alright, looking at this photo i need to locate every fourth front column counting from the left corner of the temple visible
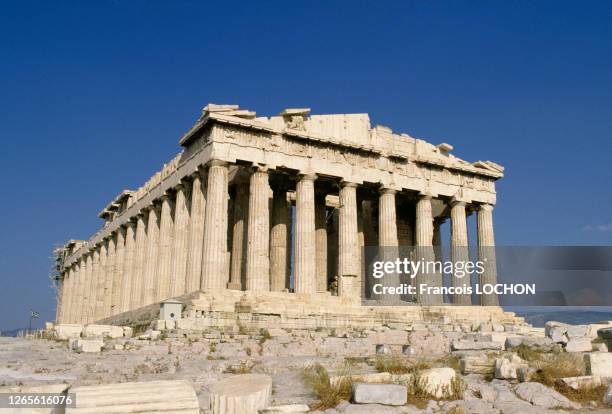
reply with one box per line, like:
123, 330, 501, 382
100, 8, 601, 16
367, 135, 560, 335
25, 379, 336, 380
338, 182, 360, 298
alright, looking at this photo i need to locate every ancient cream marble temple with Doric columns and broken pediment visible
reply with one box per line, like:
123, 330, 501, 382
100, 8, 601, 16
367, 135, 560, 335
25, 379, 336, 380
56, 104, 503, 323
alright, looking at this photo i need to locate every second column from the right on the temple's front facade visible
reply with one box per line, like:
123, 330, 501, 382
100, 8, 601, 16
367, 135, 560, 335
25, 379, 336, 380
451, 200, 472, 305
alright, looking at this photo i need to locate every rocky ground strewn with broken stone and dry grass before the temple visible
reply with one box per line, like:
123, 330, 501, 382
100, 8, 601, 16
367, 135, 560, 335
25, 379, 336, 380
0, 324, 612, 414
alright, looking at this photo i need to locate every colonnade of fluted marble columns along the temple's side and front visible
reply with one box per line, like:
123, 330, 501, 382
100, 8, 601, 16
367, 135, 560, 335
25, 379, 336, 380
58, 161, 496, 322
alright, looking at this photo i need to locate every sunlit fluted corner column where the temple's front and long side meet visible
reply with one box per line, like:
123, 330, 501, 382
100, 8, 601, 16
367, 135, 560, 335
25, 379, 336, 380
200, 160, 228, 289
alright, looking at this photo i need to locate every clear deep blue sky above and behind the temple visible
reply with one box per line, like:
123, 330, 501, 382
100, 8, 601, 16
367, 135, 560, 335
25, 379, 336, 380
0, 1, 612, 329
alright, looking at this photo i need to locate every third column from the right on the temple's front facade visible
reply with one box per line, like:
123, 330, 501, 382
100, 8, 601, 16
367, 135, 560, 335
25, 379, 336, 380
415, 194, 442, 305
